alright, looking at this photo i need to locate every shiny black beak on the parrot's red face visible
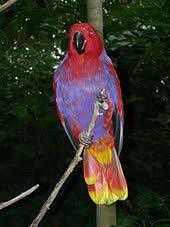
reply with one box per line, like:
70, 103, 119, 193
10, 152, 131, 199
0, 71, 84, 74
74, 32, 86, 54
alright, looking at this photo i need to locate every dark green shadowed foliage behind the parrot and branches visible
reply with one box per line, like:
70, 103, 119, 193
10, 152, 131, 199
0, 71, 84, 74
0, 0, 170, 227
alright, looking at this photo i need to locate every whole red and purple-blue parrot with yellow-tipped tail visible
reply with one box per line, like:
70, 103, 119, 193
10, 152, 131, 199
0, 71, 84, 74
53, 22, 128, 205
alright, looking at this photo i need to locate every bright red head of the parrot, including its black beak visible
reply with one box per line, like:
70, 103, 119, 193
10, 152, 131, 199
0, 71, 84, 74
68, 23, 103, 57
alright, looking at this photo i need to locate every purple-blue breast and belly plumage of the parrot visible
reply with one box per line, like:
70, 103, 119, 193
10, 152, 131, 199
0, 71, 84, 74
56, 59, 118, 141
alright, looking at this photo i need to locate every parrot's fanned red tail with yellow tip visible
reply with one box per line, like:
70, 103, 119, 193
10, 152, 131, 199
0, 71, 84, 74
83, 139, 128, 205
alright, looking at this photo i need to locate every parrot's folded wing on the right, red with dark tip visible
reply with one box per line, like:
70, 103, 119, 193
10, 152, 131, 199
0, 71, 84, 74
105, 58, 124, 155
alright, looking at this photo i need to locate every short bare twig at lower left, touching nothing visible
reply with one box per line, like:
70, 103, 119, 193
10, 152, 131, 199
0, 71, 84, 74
0, 184, 39, 210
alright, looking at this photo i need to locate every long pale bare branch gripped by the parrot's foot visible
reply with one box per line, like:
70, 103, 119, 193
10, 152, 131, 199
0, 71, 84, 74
29, 89, 107, 227
